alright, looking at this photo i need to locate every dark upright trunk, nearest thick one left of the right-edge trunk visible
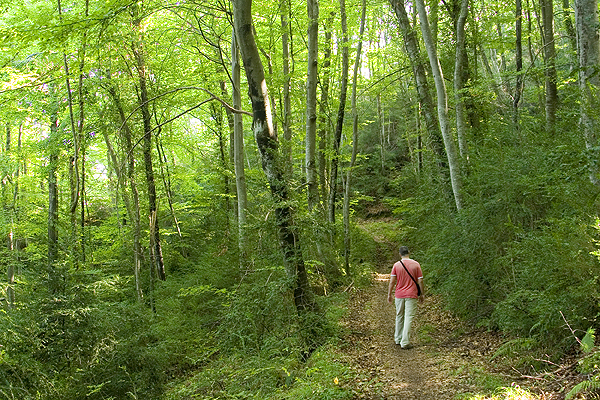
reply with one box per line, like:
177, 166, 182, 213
540, 0, 558, 135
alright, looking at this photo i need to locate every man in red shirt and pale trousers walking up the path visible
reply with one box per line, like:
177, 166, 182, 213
388, 246, 425, 350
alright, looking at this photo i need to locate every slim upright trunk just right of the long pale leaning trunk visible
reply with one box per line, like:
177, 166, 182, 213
454, 0, 469, 159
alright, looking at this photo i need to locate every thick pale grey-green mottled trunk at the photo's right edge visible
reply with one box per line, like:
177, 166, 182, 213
575, 0, 600, 186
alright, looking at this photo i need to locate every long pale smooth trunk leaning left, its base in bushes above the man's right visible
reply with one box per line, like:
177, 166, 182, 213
416, 0, 462, 211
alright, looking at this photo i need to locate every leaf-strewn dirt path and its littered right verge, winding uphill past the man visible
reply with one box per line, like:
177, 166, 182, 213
330, 219, 598, 400
